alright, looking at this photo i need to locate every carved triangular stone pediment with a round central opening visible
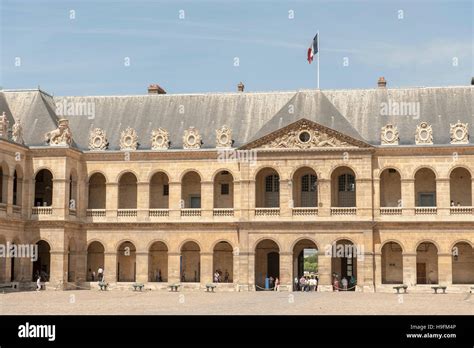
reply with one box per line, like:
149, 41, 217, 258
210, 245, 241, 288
242, 119, 372, 149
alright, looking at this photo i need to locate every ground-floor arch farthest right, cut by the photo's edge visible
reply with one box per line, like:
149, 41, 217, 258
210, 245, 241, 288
452, 242, 474, 284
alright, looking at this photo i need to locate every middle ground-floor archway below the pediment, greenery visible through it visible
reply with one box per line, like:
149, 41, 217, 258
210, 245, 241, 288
293, 239, 319, 290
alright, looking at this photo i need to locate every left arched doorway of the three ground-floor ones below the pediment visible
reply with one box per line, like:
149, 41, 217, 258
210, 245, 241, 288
255, 239, 280, 290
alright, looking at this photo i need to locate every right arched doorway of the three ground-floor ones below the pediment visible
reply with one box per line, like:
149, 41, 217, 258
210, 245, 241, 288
331, 239, 359, 291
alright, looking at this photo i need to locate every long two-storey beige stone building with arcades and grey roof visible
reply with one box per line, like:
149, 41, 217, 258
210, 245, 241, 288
0, 83, 474, 291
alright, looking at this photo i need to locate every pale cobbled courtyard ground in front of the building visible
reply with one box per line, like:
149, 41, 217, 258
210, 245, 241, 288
0, 290, 474, 315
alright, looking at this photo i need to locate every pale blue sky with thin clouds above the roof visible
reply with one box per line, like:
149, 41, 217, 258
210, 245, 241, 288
0, 0, 474, 95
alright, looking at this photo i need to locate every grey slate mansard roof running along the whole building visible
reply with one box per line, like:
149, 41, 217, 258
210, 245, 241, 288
0, 86, 474, 150
